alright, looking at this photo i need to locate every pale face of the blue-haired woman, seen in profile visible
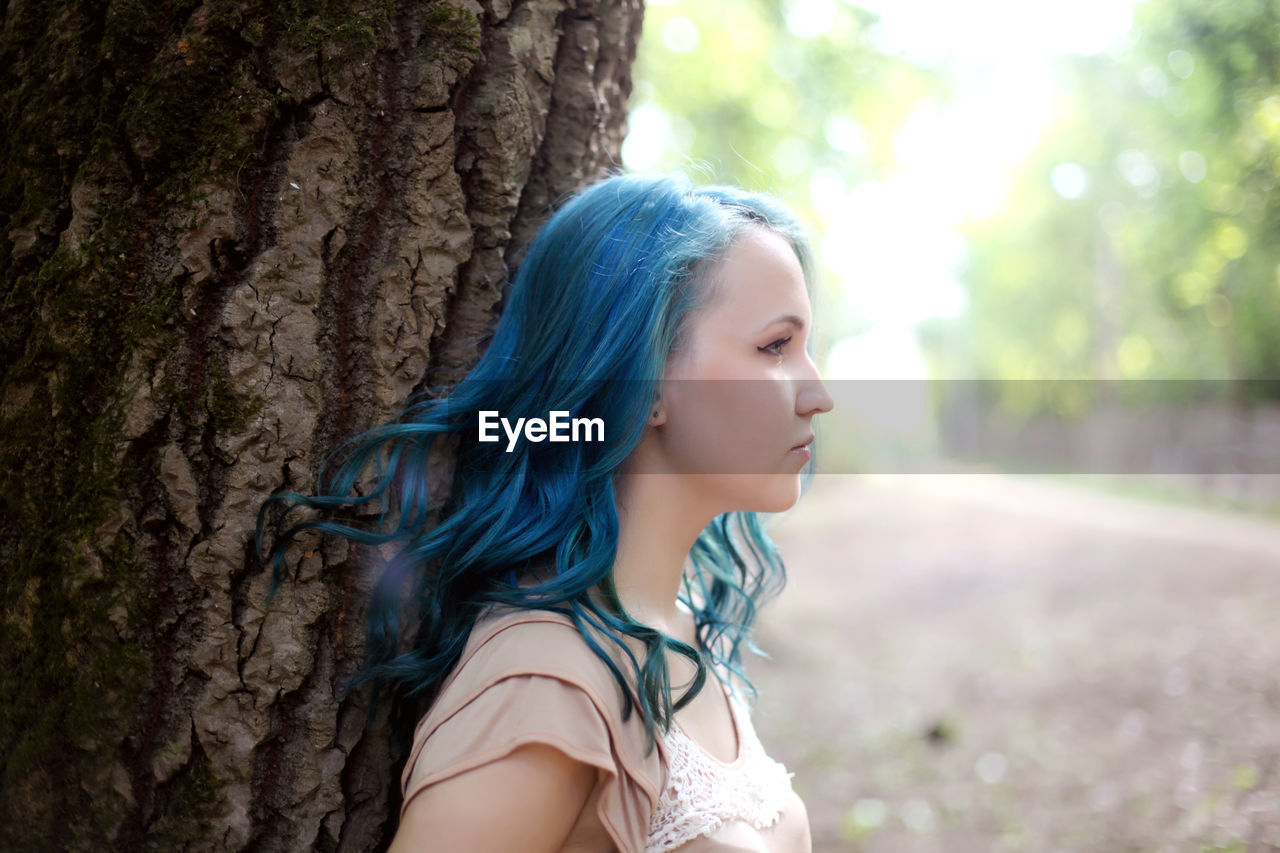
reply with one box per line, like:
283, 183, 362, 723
646, 227, 832, 515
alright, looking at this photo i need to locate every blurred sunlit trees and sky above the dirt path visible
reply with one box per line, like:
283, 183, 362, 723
622, 0, 1280, 504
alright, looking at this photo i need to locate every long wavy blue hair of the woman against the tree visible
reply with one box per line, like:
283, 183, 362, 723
255, 169, 813, 748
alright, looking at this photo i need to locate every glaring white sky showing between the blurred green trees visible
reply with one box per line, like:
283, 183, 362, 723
623, 0, 1138, 379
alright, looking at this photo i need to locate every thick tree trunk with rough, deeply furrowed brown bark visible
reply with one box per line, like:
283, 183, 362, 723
0, 0, 641, 850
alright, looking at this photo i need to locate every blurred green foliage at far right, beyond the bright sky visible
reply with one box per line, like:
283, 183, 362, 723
952, 0, 1280, 393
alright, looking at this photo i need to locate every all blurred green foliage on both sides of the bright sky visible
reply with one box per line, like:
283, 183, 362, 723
625, 0, 1280, 411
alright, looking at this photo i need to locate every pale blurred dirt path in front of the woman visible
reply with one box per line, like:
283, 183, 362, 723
751, 475, 1280, 853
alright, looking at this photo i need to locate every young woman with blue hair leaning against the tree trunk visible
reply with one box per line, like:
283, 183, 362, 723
259, 175, 832, 853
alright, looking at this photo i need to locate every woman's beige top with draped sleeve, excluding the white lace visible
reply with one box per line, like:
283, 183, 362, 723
401, 610, 809, 853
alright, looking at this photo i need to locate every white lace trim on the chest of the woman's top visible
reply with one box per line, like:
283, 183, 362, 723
645, 694, 794, 853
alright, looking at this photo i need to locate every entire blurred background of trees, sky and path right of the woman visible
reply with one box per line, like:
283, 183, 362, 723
622, 0, 1280, 850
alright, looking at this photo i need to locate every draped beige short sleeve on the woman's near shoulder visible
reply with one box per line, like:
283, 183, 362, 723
401, 616, 662, 853
